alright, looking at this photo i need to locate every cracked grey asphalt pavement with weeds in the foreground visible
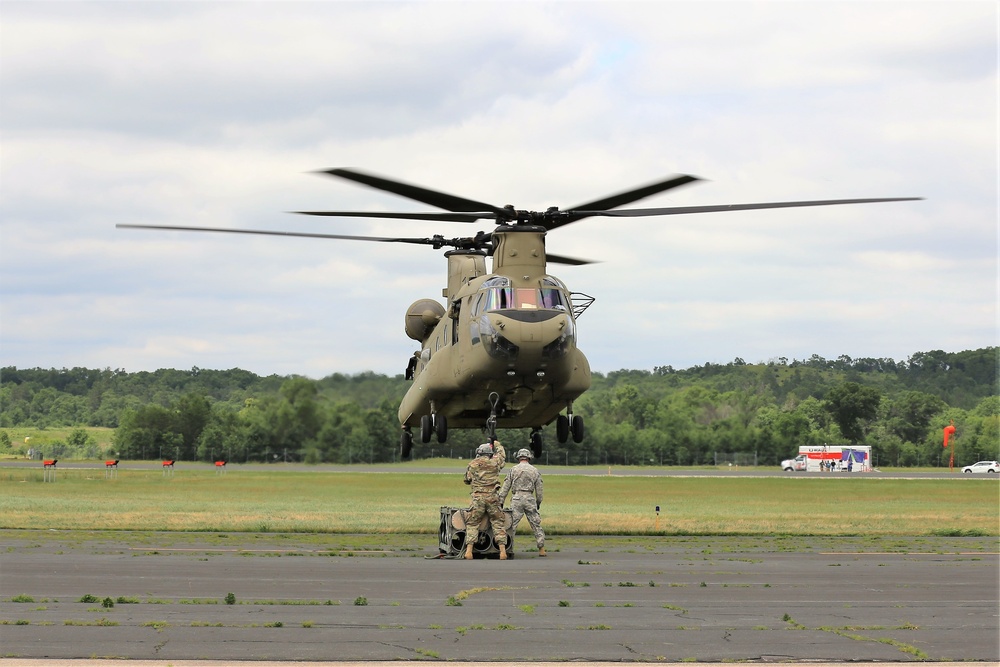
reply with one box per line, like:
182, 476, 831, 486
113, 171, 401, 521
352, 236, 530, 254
0, 531, 1000, 667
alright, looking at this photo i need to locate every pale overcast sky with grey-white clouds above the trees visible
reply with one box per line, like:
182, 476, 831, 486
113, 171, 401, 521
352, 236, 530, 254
0, 0, 998, 378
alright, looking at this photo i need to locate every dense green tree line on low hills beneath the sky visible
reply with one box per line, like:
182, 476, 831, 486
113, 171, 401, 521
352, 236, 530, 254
0, 347, 1000, 466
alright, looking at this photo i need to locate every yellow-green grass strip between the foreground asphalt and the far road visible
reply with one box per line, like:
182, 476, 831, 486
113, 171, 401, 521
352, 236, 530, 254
0, 468, 1000, 536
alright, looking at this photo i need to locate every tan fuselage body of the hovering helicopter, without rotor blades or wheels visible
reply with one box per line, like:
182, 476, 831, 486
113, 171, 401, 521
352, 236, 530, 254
399, 227, 590, 428
